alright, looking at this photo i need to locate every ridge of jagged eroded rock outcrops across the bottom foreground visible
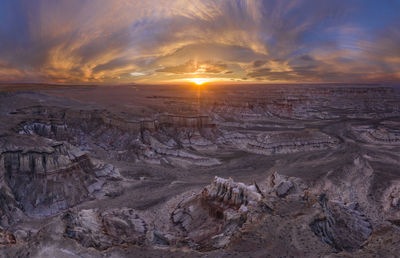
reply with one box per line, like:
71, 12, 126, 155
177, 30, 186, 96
59, 173, 384, 254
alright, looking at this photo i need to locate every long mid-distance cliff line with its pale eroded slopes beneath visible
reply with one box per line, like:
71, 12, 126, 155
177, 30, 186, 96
15, 107, 340, 166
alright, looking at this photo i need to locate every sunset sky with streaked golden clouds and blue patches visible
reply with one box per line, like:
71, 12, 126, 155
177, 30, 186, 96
0, 0, 400, 84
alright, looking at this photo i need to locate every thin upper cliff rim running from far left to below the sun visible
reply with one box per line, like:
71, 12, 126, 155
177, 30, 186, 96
13, 106, 215, 140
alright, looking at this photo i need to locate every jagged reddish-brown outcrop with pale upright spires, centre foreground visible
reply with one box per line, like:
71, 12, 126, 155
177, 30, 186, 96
171, 177, 268, 249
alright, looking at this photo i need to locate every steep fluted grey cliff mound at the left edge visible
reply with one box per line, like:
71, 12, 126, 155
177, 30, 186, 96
0, 152, 92, 215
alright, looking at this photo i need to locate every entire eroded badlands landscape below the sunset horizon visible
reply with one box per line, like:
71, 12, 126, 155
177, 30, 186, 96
0, 84, 400, 257
